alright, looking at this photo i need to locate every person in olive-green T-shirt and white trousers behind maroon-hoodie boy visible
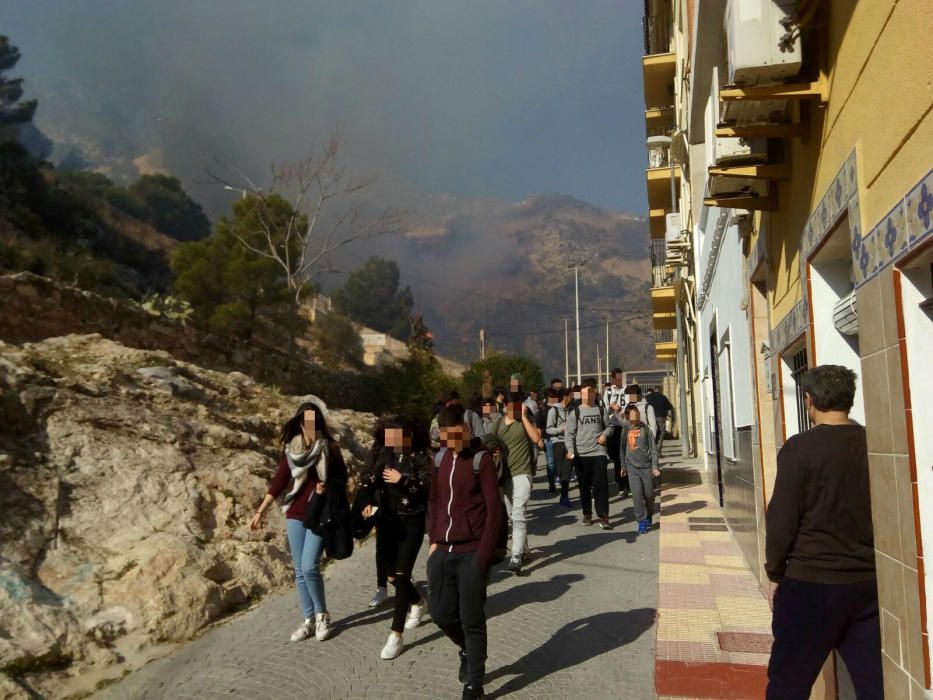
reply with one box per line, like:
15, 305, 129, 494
483, 391, 544, 574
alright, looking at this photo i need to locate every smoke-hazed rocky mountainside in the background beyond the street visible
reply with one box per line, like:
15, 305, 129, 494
355, 193, 656, 374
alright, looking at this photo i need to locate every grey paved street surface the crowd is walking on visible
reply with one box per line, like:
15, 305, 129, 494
99, 470, 659, 700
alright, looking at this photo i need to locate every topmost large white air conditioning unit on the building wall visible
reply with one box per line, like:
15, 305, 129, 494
725, 0, 802, 86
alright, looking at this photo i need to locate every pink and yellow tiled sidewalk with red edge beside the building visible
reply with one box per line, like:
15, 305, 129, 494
655, 449, 771, 698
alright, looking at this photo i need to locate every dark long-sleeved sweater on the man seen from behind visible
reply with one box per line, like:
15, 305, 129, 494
765, 423, 875, 583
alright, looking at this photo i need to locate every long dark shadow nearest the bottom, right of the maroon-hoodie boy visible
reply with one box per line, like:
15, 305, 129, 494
487, 608, 656, 697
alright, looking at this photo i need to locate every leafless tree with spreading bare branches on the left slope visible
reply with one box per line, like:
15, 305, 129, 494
208, 129, 407, 359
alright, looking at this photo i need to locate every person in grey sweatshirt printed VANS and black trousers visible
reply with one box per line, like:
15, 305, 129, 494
564, 384, 612, 530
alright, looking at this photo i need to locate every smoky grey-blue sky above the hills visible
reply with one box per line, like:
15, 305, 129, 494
0, 0, 646, 215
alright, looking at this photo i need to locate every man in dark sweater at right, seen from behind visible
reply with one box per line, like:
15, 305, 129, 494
765, 365, 889, 700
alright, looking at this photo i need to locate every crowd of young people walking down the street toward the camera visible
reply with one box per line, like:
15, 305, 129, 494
250, 372, 666, 698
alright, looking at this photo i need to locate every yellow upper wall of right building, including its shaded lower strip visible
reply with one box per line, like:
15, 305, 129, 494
764, 0, 933, 324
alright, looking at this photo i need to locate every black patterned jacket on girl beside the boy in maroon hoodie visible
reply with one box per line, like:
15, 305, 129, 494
357, 447, 431, 517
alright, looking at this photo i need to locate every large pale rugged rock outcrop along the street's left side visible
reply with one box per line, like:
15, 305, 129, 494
0, 335, 375, 697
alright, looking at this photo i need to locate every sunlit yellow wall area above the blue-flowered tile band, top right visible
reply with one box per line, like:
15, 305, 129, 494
811, 0, 933, 234
